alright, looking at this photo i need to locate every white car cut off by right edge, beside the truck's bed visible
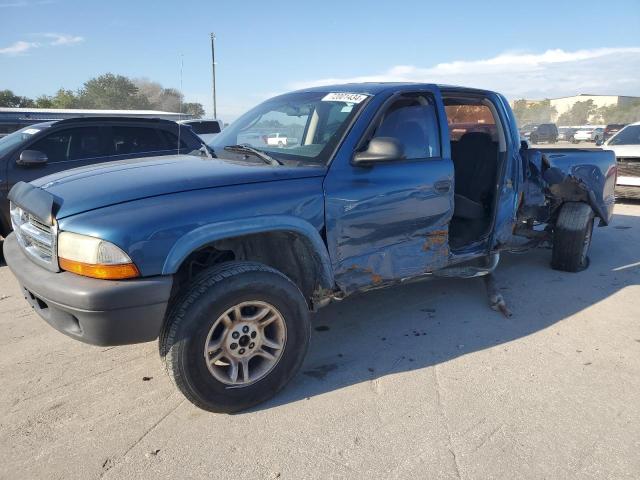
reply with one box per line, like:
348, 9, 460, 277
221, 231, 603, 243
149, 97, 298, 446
602, 122, 640, 199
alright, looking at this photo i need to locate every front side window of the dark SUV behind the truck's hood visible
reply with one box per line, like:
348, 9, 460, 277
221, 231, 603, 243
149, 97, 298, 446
29, 127, 108, 163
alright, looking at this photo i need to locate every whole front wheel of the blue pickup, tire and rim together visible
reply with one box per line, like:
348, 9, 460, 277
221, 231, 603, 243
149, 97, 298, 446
160, 262, 310, 413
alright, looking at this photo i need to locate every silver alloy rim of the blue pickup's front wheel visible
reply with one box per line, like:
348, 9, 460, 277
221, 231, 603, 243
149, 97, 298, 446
204, 300, 287, 387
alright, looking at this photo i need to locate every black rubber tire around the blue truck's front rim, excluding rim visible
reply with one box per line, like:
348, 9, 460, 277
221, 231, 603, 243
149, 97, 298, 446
159, 262, 311, 413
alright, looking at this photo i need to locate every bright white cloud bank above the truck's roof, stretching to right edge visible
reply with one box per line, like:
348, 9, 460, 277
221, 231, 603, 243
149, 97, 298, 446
292, 47, 640, 98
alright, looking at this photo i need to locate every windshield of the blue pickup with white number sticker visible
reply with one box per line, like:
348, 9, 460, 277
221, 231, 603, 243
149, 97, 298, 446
209, 92, 368, 164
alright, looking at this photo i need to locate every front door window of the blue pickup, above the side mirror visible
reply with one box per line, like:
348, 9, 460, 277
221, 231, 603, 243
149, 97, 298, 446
374, 96, 440, 160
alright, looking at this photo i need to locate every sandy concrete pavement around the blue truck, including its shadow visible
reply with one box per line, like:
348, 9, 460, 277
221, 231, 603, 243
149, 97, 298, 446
0, 204, 640, 479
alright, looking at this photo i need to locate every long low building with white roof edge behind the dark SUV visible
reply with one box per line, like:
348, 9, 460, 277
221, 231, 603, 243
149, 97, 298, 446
0, 107, 193, 137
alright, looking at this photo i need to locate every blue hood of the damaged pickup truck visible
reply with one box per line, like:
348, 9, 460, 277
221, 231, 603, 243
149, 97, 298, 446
32, 155, 326, 219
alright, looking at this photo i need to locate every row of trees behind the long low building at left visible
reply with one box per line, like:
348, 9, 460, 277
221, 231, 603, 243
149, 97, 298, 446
0, 73, 204, 118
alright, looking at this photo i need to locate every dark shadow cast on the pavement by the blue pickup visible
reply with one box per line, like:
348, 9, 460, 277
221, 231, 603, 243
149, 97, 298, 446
253, 214, 640, 410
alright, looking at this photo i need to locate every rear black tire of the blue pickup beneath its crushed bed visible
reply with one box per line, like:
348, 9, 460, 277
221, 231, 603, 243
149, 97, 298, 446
551, 202, 594, 272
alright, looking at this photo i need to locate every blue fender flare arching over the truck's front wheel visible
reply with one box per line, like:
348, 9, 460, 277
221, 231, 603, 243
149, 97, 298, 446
162, 215, 335, 290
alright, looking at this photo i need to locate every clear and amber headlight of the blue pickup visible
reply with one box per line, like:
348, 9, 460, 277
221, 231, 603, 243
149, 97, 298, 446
58, 232, 140, 280
